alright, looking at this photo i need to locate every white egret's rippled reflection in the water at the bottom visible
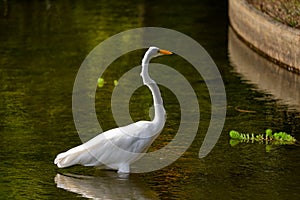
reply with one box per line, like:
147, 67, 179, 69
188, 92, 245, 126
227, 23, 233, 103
54, 171, 159, 199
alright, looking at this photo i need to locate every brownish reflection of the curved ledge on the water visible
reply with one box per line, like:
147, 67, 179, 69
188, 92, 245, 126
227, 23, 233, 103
228, 28, 300, 111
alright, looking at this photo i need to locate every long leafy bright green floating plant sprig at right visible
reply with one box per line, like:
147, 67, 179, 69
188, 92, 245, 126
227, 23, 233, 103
229, 129, 296, 146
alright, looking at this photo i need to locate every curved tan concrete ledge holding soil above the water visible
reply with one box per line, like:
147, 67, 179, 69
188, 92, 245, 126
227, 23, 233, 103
229, 0, 300, 74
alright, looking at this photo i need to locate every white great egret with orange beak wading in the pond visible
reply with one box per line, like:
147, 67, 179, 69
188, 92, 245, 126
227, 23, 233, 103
54, 47, 172, 173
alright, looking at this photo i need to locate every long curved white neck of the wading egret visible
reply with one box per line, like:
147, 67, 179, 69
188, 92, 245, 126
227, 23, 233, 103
141, 56, 166, 125
